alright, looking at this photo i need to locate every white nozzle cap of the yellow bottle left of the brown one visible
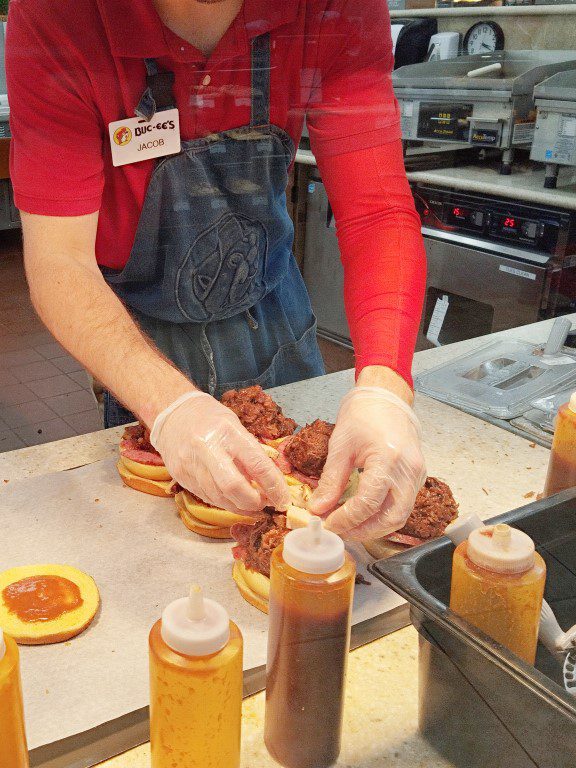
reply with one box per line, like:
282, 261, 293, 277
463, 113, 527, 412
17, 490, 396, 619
160, 584, 230, 656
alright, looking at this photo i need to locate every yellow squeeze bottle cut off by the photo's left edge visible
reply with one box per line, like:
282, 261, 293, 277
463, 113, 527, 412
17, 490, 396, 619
0, 629, 28, 768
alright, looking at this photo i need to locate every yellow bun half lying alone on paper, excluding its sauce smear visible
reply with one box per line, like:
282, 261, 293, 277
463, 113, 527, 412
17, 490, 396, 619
0, 564, 100, 645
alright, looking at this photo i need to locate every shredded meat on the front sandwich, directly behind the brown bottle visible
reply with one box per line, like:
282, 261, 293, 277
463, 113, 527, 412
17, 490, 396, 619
230, 507, 288, 576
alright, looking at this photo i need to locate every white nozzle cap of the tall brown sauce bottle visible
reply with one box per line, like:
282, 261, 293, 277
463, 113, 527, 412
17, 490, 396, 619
282, 515, 345, 573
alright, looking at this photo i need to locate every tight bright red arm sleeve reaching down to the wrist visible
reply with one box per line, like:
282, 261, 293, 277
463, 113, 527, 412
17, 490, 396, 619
310, 141, 426, 386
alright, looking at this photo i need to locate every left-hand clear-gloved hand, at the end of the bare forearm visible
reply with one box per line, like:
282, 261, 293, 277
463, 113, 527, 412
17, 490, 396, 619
150, 391, 290, 514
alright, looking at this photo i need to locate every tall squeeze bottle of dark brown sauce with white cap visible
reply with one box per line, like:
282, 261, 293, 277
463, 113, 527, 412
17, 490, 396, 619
264, 517, 356, 768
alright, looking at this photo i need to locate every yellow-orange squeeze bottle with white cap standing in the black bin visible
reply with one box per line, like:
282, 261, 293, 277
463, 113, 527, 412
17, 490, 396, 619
450, 523, 546, 664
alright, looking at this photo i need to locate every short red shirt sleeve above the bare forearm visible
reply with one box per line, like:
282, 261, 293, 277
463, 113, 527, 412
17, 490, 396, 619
6, 0, 104, 216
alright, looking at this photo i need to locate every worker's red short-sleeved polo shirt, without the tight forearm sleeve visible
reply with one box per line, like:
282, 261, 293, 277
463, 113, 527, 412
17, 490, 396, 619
7, 0, 398, 268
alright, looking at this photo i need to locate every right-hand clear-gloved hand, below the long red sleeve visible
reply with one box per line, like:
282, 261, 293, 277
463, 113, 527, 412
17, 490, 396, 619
309, 386, 426, 540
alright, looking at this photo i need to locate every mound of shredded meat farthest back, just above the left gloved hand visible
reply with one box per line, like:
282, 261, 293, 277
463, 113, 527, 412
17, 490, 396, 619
222, 386, 296, 440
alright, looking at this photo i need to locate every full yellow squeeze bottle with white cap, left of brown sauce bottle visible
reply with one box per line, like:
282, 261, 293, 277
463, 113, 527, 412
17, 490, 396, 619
149, 586, 242, 768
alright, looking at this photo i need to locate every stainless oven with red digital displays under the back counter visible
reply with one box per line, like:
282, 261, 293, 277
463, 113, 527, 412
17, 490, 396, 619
303, 177, 576, 349
